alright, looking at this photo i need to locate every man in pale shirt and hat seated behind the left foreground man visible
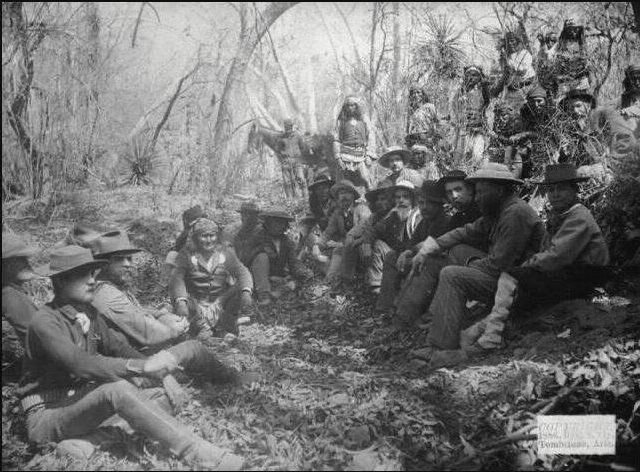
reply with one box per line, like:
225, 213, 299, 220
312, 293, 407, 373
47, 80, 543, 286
91, 231, 189, 349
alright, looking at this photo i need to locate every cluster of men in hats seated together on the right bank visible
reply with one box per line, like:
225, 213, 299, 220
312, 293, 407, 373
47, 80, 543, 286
290, 159, 609, 367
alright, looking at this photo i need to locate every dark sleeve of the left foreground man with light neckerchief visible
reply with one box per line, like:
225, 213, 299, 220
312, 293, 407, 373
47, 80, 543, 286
29, 316, 139, 381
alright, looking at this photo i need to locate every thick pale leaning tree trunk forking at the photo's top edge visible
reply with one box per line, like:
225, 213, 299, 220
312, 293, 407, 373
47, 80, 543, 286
207, 2, 297, 204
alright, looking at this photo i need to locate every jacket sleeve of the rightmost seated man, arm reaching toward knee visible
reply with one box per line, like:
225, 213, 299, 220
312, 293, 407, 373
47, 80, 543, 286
522, 211, 591, 272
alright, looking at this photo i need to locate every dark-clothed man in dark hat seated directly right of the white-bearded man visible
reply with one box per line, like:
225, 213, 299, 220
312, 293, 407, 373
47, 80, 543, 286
376, 180, 448, 322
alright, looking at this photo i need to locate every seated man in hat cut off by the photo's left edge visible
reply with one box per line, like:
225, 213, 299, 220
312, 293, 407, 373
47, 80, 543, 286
2, 233, 38, 378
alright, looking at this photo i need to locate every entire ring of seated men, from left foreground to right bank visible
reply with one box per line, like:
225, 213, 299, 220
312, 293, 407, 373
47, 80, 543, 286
2, 156, 609, 464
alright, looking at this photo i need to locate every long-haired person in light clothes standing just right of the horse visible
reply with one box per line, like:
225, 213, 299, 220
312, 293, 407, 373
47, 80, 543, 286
333, 95, 376, 193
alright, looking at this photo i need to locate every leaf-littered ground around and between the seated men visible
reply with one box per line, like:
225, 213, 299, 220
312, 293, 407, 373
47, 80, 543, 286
2, 184, 640, 470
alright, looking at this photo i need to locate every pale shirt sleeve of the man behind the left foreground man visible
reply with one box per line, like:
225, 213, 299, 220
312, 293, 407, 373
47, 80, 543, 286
93, 284, 174, 346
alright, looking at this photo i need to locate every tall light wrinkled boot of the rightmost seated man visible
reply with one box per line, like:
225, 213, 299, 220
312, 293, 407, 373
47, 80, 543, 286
460, 272, 518, 350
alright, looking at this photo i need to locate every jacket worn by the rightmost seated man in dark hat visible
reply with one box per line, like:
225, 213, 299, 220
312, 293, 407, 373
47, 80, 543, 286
522, 204, 609, 272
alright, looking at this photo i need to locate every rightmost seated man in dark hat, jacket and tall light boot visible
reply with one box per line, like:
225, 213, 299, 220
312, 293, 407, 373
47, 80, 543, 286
460, 164, 609, 352
